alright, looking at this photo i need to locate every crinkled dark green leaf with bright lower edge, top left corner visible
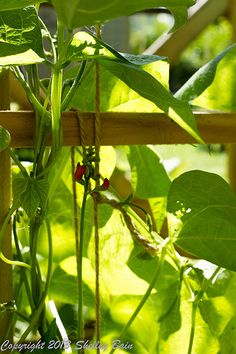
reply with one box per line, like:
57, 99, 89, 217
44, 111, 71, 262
0, 6, 44, 66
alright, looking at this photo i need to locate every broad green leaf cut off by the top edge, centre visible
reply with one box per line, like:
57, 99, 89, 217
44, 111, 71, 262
51, 0, 195, 29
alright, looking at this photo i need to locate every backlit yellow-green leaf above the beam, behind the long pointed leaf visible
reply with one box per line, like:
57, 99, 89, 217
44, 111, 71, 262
66, 55, 169, 112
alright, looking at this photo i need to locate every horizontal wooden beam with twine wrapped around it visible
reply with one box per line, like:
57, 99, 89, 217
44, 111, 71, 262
0, 111, 236, 147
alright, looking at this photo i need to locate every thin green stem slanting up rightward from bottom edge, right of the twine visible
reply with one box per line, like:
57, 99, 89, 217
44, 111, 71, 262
109, 239, 170, 354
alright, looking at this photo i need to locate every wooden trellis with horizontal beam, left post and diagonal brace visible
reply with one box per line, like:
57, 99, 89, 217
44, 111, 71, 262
0, 0, 236, 340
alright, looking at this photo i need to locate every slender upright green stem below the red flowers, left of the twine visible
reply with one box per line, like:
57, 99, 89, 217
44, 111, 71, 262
76, 181, 88, 340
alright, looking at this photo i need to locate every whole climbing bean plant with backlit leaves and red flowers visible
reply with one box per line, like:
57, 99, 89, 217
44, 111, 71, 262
0, 0, 236, 354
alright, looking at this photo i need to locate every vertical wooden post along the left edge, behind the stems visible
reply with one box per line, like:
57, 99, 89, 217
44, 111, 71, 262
0, 71, 13, 346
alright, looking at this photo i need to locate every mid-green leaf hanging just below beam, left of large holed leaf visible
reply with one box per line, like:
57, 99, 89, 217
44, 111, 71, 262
128, 145, 170, 198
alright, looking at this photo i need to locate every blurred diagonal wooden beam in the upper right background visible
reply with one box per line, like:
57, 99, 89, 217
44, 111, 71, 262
144, 0, 228, 62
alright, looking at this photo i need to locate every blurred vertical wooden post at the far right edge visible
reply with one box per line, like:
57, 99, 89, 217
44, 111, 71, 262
227, 0, 236, 193
